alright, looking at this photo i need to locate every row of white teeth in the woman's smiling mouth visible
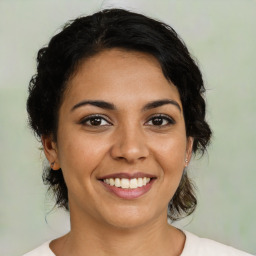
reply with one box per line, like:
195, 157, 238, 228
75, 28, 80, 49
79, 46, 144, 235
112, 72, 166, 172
104, 177, 150, 188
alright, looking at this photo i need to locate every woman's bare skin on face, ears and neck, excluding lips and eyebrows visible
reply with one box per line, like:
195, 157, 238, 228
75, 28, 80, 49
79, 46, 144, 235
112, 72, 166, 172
42, 49, 193, 256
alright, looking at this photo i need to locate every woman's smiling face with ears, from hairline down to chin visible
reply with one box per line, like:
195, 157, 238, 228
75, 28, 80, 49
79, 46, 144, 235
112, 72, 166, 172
45, 49, 192, 228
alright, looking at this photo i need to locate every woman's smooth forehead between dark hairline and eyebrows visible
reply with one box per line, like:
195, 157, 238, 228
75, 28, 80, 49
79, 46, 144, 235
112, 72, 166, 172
64, 48, 180, 109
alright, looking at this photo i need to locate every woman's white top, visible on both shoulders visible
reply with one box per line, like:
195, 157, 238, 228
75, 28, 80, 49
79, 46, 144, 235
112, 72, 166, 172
23, 231, 253, 256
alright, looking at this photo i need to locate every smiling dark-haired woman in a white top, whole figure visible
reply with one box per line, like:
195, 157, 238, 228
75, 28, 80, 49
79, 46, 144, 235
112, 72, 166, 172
23, 9, 252, 256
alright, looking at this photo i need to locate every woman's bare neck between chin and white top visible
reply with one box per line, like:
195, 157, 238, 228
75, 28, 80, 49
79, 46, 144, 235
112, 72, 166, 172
51, 206, 185, 256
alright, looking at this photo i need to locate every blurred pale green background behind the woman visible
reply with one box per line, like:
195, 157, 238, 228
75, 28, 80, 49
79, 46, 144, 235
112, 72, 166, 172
0, 0, 256, 256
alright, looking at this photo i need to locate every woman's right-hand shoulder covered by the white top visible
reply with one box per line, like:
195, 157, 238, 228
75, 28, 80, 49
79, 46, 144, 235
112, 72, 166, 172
181, 231, 252, 256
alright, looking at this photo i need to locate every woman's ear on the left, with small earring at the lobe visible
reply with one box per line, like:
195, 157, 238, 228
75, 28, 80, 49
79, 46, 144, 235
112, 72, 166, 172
41, 135, 60, 170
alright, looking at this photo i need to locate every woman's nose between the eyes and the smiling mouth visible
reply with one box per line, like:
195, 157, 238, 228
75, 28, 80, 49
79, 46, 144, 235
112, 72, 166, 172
111, 125, 149, 163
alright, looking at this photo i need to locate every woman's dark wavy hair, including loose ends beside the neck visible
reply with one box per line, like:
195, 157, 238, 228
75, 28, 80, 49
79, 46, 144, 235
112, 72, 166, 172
27, 9, 211, 221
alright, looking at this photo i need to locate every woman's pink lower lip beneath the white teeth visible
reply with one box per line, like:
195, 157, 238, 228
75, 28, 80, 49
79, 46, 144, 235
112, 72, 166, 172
101, 179, 155, 199
